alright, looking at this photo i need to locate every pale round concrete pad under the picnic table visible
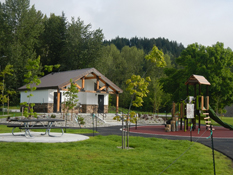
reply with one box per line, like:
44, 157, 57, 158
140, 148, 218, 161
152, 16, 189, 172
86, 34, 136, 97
0, 132, 89, 143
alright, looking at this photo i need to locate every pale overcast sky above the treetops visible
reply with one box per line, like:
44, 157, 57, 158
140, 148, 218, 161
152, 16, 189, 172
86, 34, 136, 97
1, 0, 233, 49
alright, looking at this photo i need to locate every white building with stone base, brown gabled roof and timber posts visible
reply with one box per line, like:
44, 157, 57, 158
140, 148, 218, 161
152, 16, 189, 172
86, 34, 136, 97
18, 68, 123, 113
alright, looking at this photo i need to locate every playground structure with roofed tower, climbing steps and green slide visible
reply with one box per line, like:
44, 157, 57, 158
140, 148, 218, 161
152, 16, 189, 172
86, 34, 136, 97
165, 75, 233, 132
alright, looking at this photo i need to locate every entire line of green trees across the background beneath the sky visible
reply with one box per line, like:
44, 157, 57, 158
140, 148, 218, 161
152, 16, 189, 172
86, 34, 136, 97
0, 0, 233, 112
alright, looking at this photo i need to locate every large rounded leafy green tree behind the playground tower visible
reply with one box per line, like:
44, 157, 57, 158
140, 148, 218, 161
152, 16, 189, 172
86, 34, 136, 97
161, 42, 233, 111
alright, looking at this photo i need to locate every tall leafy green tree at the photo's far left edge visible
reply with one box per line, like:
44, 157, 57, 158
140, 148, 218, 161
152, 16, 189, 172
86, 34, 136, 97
0, 0, 43, 104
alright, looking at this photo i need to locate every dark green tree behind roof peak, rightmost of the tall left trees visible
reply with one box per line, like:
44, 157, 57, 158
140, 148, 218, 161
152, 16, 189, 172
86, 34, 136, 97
61, 18, 103, 70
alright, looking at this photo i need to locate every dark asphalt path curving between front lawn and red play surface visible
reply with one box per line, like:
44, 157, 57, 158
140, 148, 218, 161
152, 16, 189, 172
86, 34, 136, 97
82, 126, 233, 161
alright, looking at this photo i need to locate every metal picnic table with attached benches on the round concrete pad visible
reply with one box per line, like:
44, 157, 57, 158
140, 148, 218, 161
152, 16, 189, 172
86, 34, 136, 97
7, 118, 67, 137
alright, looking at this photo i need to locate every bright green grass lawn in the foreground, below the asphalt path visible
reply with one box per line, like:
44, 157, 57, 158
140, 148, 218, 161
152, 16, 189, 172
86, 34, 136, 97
0, 135, 233, 175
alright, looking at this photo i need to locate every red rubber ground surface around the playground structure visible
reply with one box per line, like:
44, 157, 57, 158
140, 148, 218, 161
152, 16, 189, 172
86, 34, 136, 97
130, 125, 233, 138
